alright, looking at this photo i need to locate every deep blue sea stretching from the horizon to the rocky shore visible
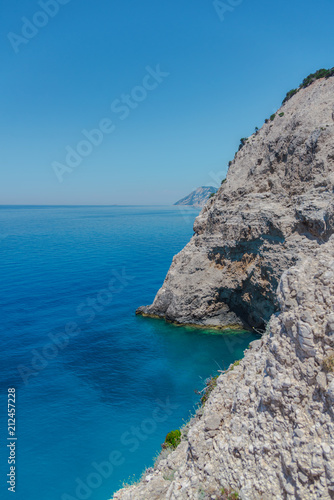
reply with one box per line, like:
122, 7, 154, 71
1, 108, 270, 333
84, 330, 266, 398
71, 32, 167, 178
0, 206, 255, 500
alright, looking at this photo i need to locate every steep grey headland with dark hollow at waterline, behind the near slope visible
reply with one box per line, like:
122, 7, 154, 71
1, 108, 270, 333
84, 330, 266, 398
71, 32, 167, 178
138, 78, 334, 327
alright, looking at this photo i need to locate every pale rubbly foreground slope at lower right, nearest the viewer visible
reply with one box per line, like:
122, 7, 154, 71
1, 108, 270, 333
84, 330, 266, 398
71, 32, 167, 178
114, 240, 334, 500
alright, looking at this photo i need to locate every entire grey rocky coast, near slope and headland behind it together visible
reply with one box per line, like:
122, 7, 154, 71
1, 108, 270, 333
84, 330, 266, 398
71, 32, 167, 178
114, 78, 334, 500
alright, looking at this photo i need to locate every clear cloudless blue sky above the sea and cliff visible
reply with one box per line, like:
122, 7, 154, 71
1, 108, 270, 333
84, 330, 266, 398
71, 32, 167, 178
0, 0, 334, 205
